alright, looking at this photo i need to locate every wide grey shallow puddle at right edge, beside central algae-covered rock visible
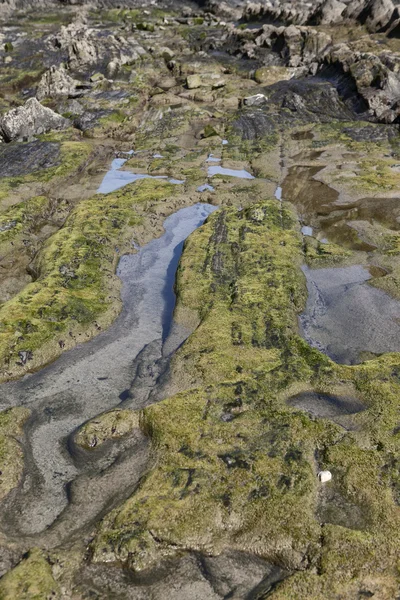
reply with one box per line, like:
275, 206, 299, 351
299, 265, 400, 364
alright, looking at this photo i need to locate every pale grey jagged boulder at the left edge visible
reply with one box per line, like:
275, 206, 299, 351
0, 98, 70, 142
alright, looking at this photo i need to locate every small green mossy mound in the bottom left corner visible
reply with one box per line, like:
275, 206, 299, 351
0, 548, 60, 600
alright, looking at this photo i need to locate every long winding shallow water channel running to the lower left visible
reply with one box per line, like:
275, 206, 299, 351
0, 203, 218, 543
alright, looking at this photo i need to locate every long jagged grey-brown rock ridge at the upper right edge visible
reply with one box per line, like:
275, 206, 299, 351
225, 11, 400, 123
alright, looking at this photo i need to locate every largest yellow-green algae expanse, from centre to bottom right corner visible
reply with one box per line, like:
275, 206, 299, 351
92, 201, 400, 599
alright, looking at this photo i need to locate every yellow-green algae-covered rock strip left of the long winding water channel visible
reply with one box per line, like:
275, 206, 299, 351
0, 180, 176, 378
